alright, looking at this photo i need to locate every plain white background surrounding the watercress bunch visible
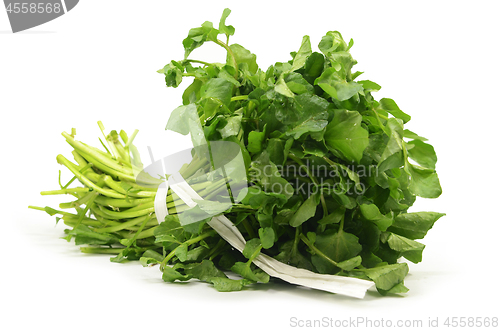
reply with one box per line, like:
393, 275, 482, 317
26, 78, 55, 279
0, 0, 500, 330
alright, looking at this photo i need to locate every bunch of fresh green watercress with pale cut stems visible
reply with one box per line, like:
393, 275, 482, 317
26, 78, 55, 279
32, 9, 444, 294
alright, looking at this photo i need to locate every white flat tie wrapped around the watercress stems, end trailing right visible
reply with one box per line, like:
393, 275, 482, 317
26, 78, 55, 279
155, 173, 375, 299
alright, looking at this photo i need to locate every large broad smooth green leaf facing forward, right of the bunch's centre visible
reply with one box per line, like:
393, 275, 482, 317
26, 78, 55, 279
324, 109, 369, 162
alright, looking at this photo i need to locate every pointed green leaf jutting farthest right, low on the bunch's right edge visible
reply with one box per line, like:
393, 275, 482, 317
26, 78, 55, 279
388, 211, 446, 239
